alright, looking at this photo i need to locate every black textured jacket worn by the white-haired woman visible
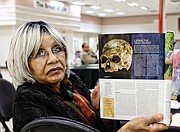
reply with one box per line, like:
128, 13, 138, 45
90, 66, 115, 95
13, 73, 102, 132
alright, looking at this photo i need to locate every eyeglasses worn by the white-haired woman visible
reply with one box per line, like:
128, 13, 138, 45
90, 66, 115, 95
30, 45, 65, 58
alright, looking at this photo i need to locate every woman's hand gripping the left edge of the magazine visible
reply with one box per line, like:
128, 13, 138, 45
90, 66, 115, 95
90, 83, 100, 111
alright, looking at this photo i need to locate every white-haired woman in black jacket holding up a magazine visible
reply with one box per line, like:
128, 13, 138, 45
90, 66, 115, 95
8, 21, 168, 132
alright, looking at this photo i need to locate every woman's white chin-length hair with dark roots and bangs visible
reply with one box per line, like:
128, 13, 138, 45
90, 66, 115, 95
7, 21, 70, 86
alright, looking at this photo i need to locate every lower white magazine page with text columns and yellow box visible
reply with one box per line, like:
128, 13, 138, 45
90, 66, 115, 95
100, 79, 171, 124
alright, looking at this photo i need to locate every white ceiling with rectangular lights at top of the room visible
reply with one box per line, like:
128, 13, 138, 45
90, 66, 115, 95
57, 0, 180, 18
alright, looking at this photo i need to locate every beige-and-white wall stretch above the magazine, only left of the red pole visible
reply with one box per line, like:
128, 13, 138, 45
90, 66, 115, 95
102, 15, 158, 33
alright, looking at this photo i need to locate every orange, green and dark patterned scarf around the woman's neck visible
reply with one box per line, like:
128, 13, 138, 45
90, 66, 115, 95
48, 78, 96, 126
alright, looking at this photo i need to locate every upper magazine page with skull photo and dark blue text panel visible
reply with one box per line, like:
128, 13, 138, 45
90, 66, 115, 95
99, 33, 165, 80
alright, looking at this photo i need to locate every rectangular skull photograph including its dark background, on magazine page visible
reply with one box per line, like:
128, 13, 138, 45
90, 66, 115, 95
99, 35, 133, 78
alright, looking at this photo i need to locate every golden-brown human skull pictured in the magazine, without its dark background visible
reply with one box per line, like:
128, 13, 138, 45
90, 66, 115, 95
100, 39, 133, 72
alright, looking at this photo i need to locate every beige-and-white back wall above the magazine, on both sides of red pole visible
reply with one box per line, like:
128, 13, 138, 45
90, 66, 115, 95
102, 14, 180, 40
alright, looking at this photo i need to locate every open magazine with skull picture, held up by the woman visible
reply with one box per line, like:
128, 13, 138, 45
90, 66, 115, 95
99, 33, 172, 125
